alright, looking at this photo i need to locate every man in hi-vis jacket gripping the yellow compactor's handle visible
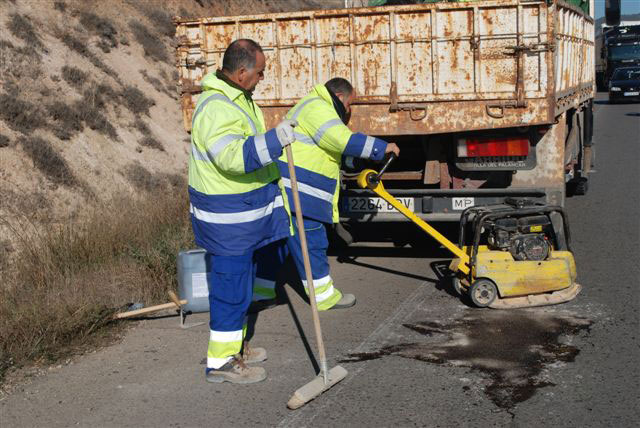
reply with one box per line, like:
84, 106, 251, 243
254, 78, 400, 311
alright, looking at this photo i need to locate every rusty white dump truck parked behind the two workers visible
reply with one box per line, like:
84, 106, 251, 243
175, 0, 595, 234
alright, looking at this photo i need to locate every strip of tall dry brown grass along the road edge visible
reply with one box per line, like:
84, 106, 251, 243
0, 189, 193, 382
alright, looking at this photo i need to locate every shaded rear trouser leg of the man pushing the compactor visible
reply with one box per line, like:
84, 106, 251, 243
253, 239, 289, 301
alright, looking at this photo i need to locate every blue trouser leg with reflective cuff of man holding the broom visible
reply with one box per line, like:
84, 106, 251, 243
205, 252, 254, 369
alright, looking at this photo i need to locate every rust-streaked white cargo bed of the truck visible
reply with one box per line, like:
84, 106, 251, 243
177, 0, 593, 135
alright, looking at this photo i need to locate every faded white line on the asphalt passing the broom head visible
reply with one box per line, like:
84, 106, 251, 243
277, 281, 433, 428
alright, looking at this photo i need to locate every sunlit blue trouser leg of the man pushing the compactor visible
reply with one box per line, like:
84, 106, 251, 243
287, 217, 342, 311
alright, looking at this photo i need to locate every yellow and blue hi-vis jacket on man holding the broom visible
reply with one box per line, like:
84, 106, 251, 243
189, 73, 290, 255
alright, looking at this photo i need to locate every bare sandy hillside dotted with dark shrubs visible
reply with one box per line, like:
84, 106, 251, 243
0, 0, 335, 261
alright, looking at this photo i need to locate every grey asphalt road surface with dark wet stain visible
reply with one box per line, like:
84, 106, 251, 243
0, 95, 640, 427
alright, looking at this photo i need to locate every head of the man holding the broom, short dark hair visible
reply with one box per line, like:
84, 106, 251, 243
222, 39, 265, 92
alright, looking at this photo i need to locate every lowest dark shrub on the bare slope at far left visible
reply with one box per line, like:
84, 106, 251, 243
18, 137, 78, 186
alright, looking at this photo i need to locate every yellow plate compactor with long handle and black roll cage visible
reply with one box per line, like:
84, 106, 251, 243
358, 155, 582, 309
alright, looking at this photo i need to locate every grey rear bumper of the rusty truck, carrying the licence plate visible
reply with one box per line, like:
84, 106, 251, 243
340, 188, 557, 223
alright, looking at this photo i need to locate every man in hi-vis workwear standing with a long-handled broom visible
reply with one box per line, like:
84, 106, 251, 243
189, 39, 295, 383
